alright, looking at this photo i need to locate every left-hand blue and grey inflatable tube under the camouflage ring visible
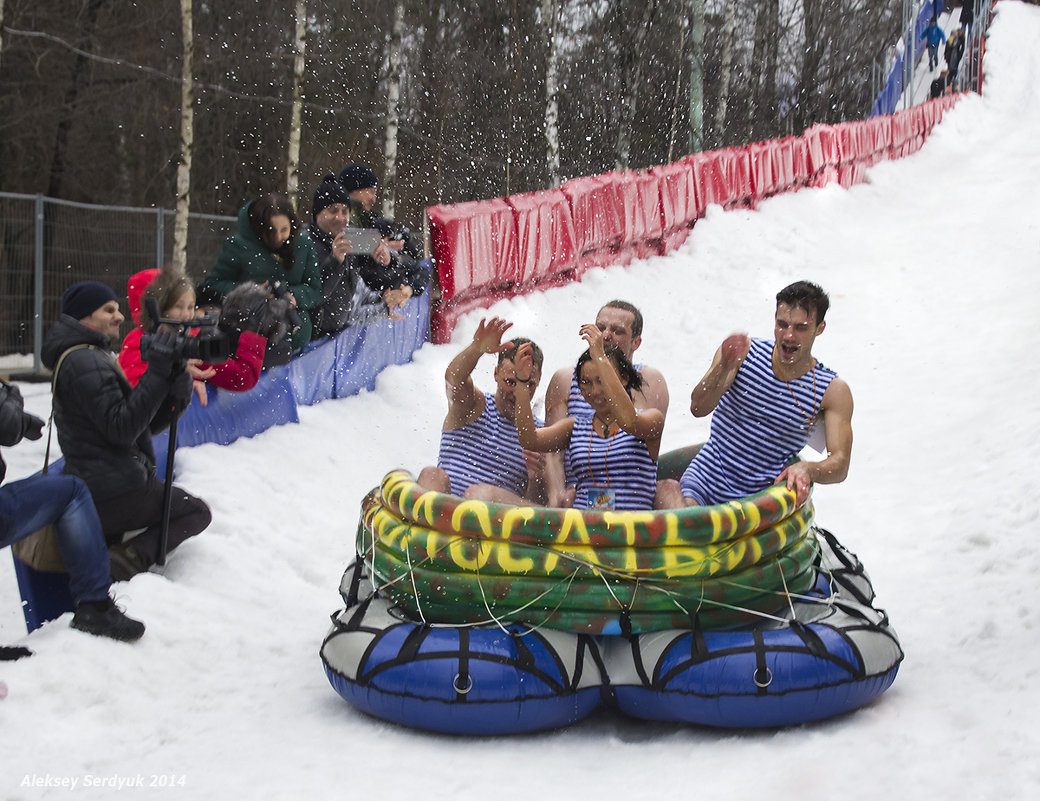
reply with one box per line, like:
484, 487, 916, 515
321, 563, 605, 734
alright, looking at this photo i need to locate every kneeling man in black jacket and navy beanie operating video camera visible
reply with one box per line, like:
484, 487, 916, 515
43, 281, 211, 580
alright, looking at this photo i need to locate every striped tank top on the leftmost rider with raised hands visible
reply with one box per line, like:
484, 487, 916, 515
437, 392, 542, 495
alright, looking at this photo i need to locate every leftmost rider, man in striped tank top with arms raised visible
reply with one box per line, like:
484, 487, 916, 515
418, 317, 544, 500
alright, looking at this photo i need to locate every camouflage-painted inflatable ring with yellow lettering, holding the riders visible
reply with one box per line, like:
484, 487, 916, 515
358, 471, 818, 634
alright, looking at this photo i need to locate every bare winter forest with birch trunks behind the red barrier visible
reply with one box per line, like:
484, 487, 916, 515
0, 0, 903, 234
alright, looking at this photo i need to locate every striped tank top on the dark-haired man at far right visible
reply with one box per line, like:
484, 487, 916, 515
680, 339, 837, 505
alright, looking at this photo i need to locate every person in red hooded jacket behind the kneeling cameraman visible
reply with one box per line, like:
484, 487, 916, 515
120, 266, 289, 406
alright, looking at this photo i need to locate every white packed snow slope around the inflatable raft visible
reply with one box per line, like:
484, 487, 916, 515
0, 0, 1040, 801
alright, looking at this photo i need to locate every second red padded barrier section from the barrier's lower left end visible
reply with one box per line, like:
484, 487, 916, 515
505, 189, 578, 284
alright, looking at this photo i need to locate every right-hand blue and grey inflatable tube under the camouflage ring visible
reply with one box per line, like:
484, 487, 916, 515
603, 529, 903, 728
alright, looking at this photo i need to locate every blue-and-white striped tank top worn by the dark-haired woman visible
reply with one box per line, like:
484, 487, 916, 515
565, 414, 657, 511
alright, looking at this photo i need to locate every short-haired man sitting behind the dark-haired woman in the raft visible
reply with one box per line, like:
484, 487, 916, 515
545, 301, 668, 507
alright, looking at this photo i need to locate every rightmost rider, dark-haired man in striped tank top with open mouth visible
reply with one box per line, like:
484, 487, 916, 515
657, 281, 853, 509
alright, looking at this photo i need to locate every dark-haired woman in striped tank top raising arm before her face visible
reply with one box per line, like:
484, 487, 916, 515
516, 324, 665, 510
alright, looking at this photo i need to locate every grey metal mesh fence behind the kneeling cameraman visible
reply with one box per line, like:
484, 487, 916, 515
0, 192, 237, 374
